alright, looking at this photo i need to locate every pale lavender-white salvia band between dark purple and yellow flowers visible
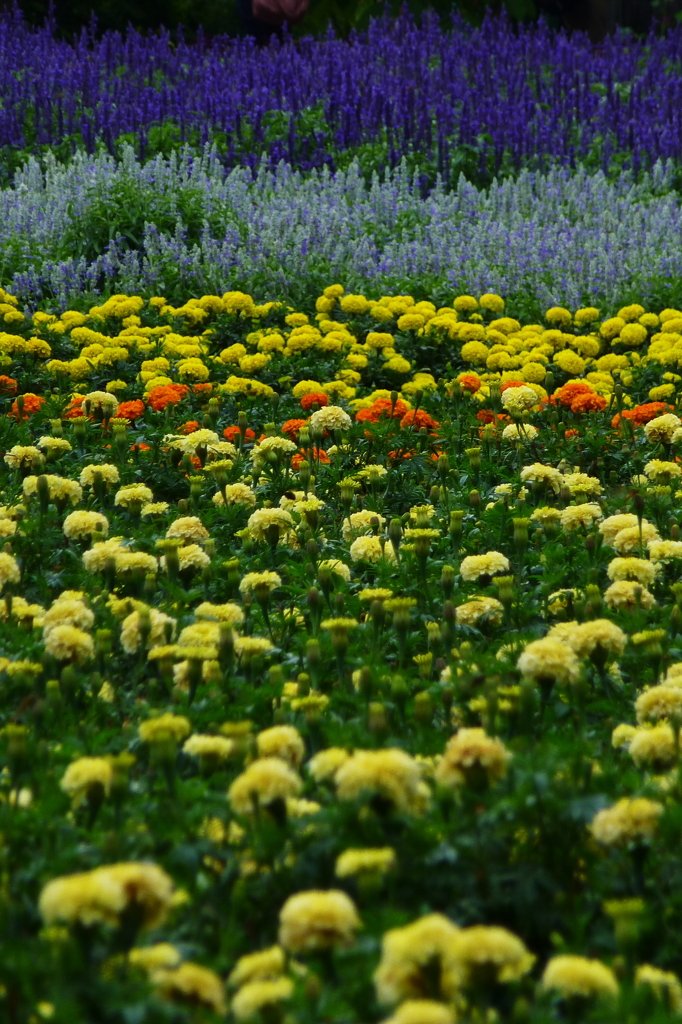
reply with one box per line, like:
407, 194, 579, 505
0, 148, 682, 307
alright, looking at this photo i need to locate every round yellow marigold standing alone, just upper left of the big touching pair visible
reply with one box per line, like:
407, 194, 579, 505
280, 889, 360, 952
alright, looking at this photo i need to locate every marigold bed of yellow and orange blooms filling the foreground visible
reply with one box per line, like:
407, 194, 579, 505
0, 285, 682, 1024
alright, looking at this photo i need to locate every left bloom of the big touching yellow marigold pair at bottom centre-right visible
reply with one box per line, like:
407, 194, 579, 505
374, 913, 460, 1006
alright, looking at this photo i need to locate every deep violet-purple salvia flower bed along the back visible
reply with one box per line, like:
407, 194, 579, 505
0, 9, 682, 183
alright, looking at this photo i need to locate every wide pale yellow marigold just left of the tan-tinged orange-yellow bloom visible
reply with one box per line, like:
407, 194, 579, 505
334, 748, 429, 814
